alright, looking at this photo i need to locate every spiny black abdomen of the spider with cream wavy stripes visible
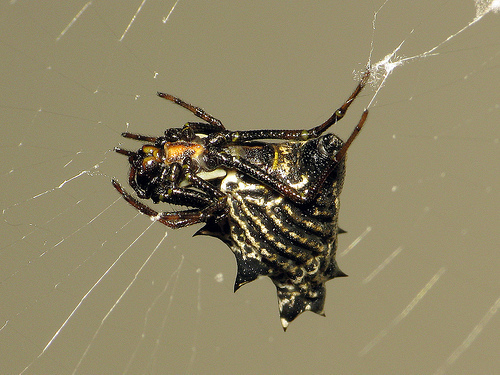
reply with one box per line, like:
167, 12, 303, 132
220, 139, 345, 328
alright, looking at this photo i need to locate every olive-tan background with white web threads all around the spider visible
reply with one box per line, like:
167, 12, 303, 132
0, 0, 500, 374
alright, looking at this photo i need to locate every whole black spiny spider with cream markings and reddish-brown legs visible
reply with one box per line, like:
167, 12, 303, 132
112, 69, 370, 330
